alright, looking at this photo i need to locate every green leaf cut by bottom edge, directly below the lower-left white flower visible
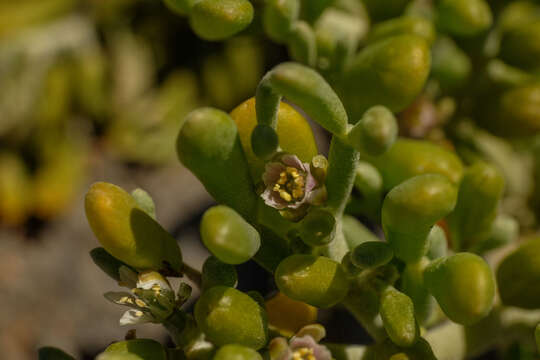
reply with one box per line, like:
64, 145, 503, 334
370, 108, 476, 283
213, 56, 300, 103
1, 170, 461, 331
98, 339, 167, 360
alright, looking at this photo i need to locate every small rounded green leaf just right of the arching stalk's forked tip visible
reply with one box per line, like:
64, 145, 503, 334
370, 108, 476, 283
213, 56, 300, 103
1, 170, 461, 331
347, 106, 398, 156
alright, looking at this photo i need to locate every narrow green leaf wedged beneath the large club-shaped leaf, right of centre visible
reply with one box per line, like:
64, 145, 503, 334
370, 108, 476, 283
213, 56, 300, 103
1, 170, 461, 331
401, 258, 437, 324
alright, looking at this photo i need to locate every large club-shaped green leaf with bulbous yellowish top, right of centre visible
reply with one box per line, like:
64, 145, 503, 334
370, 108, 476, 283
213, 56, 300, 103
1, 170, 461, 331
382, 174, 457, 262
